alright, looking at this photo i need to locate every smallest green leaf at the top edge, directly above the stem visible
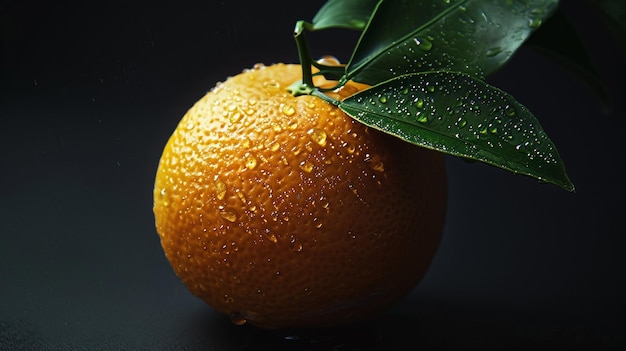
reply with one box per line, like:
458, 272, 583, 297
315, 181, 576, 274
311, 0, 379, 30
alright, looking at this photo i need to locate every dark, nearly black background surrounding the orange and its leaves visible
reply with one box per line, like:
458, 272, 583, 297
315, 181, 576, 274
0, 0, 626, 351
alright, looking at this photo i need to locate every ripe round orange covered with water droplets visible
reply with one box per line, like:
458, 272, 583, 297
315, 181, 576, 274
154, 64, 446, 329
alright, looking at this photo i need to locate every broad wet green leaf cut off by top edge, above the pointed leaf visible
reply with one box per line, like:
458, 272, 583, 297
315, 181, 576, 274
346, 0, 558, 85
